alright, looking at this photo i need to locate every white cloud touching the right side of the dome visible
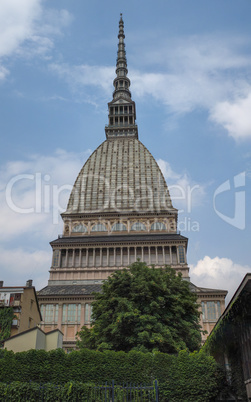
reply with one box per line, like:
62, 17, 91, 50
157, 159, 206, 213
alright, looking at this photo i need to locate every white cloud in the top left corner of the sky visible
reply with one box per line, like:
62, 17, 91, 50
0, 0, 72, 80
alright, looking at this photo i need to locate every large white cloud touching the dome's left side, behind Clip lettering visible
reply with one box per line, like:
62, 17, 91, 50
0, 150, 90, 241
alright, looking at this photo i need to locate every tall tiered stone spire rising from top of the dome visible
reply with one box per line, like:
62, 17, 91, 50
105, 14, 138, 139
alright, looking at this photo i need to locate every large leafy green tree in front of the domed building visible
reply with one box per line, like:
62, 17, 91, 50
77, 261, 201, 353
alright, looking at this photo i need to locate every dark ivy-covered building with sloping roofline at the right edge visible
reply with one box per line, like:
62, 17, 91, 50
209, 273, 251, 401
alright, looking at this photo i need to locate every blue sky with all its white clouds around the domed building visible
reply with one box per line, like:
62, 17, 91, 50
0, 0, 251, 302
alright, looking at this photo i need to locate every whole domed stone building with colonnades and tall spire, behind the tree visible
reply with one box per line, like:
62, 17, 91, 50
38, 16, 227, 349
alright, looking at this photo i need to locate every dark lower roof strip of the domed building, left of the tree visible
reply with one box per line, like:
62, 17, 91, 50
37, 285, 102, 297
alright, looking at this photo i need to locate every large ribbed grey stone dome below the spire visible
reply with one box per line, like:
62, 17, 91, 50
65, 137, 173, 214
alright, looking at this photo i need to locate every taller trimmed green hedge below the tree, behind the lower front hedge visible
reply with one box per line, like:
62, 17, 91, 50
0, 349, 221, 402
